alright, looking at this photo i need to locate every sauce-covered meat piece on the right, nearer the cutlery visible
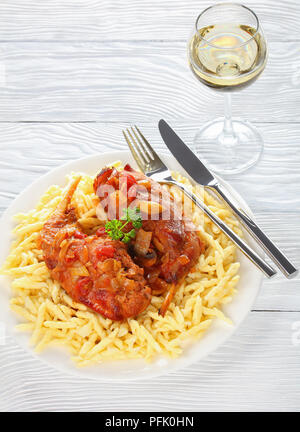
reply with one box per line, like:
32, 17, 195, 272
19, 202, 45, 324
94, 164, 205, 315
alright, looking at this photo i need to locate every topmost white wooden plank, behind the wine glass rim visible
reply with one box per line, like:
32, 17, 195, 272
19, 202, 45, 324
0, 0, 300, 40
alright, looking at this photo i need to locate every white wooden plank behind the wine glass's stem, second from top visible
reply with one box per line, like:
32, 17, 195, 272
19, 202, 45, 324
0, 42, 300, 121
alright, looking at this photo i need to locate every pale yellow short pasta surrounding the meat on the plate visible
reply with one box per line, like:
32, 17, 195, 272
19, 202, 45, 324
1, 163, 241, 366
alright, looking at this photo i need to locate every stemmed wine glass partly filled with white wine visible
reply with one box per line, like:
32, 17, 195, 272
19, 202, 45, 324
188, 3, 267, 174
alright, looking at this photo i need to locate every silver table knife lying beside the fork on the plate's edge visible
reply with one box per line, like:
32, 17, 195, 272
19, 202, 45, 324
158, 120, 298, 278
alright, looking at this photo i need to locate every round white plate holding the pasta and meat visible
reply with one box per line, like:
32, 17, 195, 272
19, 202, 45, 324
0, 151, 262, 381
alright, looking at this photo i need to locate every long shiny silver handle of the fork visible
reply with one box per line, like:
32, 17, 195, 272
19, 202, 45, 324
164, 180, 276, 278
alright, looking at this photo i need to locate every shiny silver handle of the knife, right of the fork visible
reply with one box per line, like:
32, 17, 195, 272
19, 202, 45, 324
210, 184, 298, 278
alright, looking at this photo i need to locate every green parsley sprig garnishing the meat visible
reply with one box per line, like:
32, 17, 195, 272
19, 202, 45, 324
105, 207, 142, 243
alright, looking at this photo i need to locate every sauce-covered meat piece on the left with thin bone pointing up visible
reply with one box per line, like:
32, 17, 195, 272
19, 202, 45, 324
39, 178, 151, 320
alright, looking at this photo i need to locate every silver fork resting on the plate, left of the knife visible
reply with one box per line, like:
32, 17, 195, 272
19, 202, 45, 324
122, 126, 276, 277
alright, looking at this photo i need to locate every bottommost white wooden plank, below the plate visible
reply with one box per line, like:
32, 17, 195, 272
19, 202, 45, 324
0, 312, 300, 412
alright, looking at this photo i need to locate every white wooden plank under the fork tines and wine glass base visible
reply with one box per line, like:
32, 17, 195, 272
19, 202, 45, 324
0, 123, 300, 311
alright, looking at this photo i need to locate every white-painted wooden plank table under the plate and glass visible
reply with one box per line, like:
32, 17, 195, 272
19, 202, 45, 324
0, 0, 300, 411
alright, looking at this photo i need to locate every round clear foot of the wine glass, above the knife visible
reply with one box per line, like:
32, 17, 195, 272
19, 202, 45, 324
194, 118, 263, 175
